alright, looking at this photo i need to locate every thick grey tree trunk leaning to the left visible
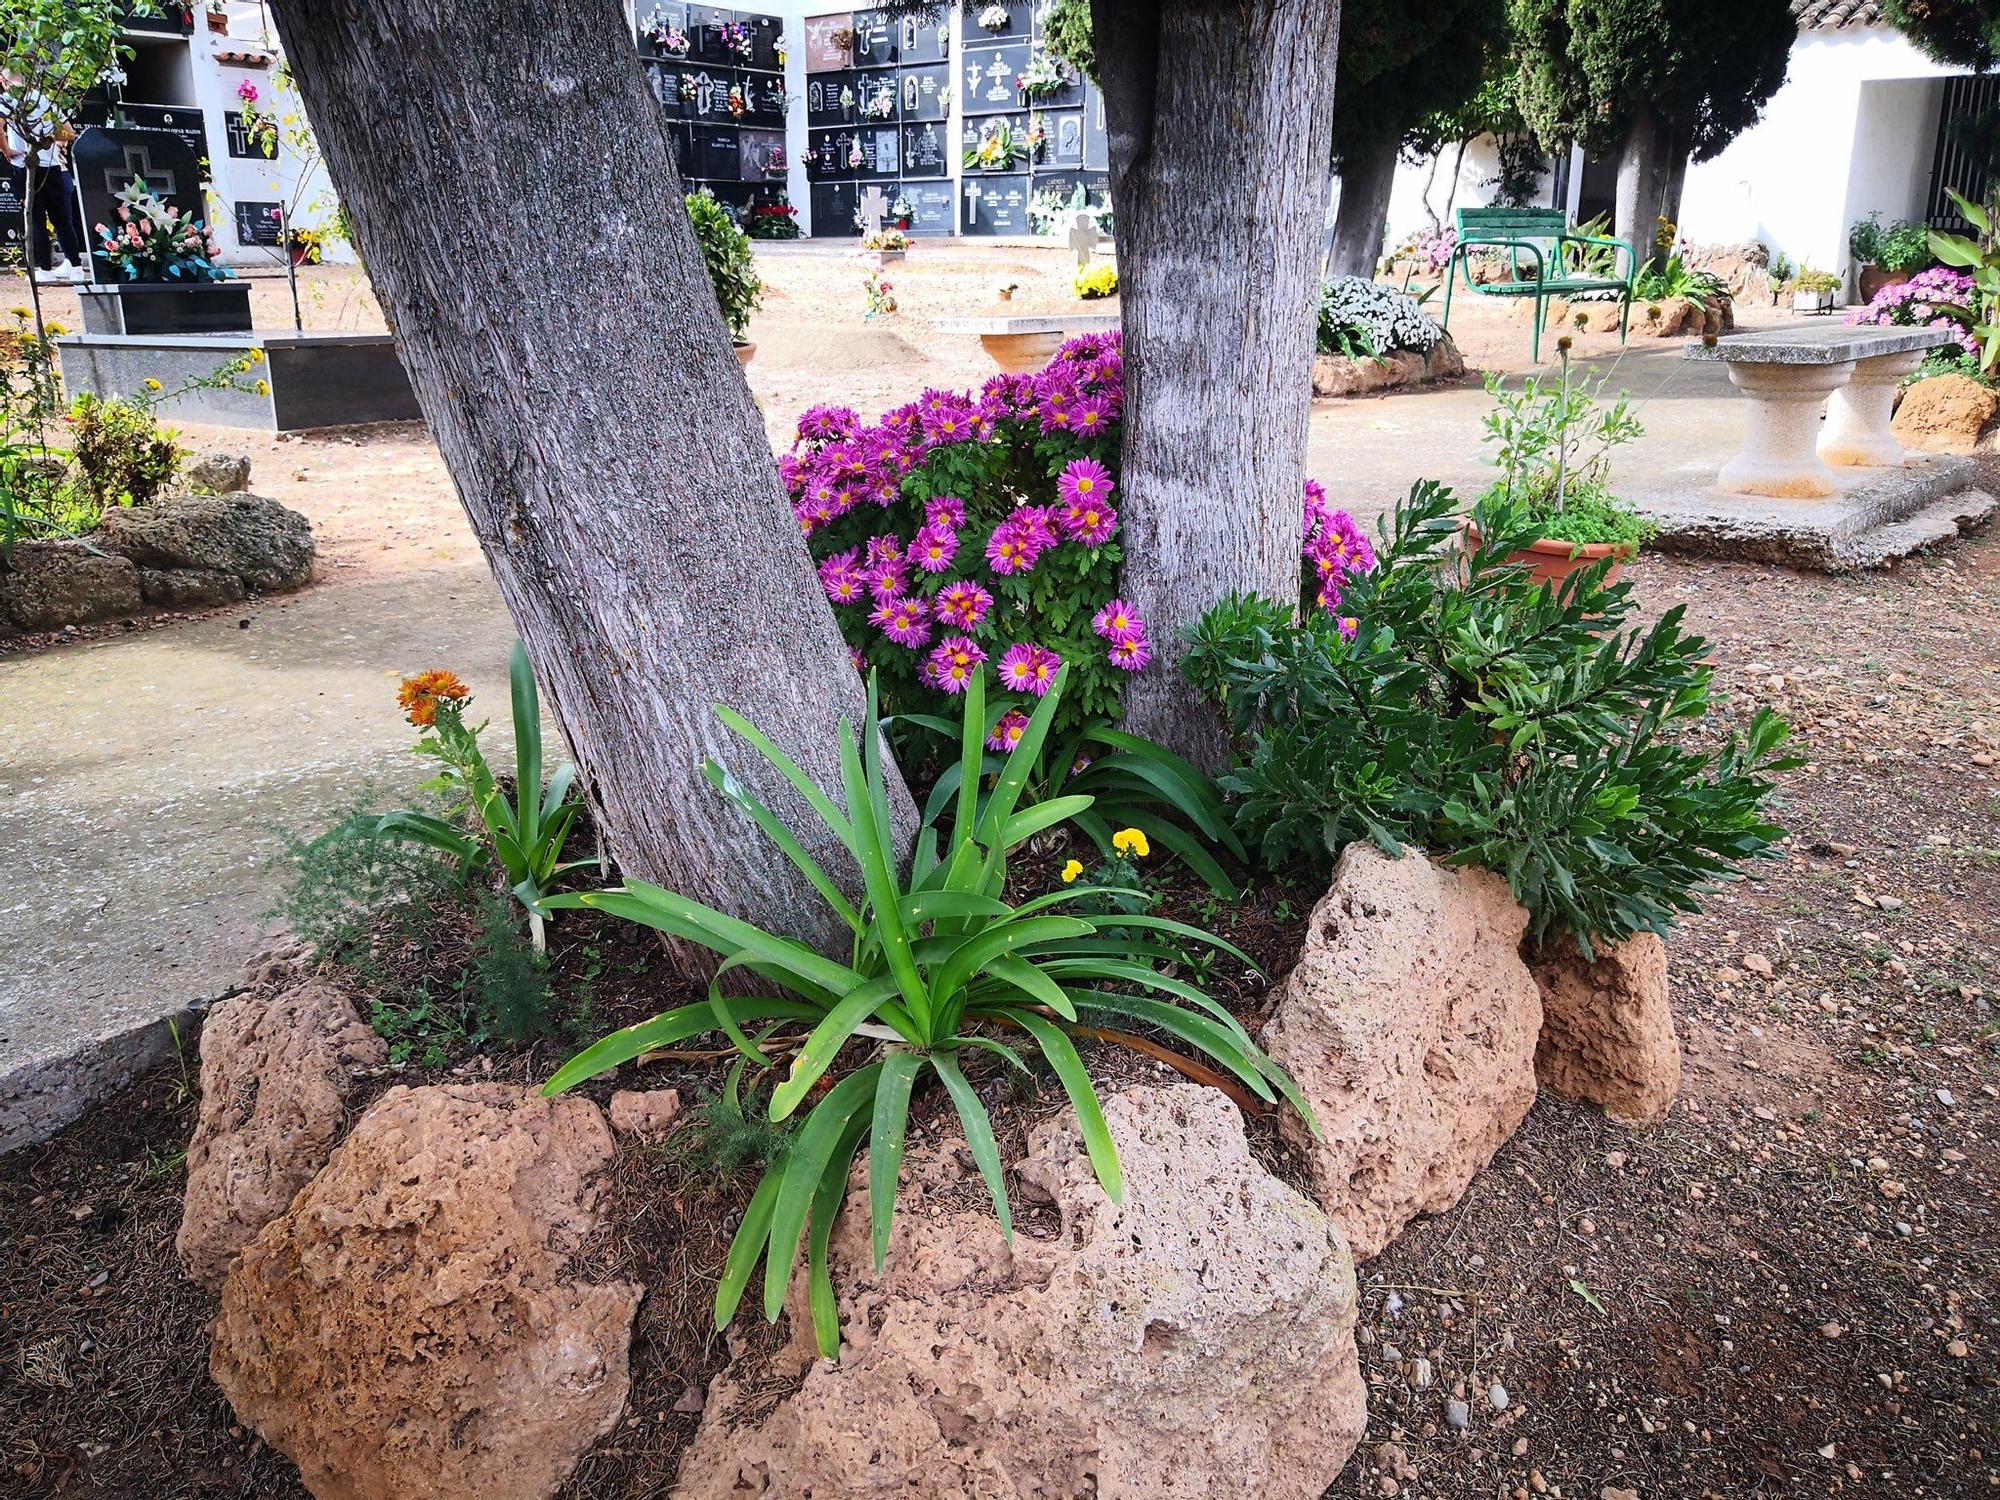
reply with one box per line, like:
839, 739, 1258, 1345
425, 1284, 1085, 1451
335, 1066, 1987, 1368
274, 0, 914, 970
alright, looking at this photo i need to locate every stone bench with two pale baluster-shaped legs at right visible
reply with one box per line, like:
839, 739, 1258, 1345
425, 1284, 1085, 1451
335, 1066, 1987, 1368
1686, 324, 1956, 500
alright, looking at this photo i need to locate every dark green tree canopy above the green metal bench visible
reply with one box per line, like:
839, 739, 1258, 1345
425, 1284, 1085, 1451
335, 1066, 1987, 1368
1508, 0, 1798, 162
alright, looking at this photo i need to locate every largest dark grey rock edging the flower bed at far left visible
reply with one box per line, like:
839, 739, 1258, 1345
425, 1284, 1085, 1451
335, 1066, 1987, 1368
90, 494, 312, 594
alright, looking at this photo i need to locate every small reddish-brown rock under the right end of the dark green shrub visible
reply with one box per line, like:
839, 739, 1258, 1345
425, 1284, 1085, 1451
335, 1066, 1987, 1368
1534, 932, 1680, 1126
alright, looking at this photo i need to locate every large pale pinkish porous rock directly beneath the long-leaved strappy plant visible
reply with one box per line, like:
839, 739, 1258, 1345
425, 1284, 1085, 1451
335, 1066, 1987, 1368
674, 1082, 1366, 1500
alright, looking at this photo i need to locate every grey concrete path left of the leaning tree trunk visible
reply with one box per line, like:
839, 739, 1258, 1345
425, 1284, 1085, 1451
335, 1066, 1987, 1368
0, 562, 514, 1150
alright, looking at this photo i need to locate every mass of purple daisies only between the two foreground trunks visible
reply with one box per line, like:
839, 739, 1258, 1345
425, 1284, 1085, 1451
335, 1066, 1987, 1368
778, 334, 1152, 704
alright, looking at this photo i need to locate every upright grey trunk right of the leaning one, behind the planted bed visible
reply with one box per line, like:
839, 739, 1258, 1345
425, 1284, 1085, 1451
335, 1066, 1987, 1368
1092, 0, 1340, 764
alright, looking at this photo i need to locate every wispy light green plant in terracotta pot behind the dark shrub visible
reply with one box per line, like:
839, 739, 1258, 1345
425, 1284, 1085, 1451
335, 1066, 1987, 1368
1466, 350, 1658, 588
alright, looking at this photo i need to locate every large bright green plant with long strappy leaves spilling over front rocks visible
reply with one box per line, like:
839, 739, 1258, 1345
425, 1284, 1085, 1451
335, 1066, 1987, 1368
546, 670, 1310, 1356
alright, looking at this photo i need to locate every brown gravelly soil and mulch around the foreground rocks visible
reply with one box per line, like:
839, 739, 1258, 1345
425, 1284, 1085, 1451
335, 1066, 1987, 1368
0, 512, 2000, 1500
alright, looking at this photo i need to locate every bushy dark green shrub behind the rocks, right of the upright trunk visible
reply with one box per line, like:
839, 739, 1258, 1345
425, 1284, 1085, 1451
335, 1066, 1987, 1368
1184, 482, 1798, 954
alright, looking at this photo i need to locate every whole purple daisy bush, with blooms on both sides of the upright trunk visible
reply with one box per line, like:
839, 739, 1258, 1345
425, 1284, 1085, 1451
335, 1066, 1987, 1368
778, 332, 1372, 750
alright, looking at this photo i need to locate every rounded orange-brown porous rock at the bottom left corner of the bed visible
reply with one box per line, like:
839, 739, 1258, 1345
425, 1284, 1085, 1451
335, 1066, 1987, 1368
210, 1084, 640, 1500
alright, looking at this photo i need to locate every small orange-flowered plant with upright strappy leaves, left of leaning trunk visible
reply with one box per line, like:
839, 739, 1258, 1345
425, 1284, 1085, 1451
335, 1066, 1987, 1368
374, 642, 590, 952
